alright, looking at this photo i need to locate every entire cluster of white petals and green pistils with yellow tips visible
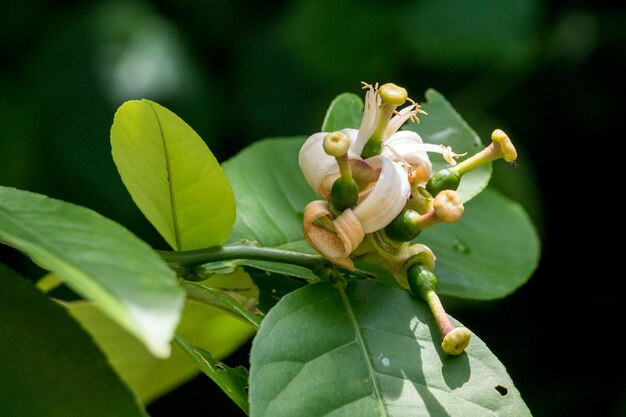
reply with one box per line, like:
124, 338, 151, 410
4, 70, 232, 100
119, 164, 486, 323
299, 83, 517, 354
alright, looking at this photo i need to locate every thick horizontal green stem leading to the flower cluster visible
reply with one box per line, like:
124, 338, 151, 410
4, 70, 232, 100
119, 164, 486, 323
157, 245, 328, 272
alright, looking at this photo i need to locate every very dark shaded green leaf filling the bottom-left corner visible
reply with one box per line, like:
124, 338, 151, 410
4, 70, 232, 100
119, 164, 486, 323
0, 264, 147, 417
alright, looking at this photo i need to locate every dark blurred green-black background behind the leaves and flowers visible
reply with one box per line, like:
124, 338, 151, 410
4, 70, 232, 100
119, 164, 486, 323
0, 0, 626, 417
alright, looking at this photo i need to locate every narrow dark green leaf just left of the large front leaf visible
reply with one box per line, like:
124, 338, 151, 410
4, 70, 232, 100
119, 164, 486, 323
176, 335, 248, 414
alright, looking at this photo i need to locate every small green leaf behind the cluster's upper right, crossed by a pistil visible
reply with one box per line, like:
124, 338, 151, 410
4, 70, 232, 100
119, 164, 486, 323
404, 89, 491, 202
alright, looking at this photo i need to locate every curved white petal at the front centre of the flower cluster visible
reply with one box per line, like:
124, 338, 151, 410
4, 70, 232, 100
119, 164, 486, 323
353, 157, 411, 233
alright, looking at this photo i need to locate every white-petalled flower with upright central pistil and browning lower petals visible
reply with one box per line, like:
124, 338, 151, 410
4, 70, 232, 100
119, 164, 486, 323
299, 83, 460, 268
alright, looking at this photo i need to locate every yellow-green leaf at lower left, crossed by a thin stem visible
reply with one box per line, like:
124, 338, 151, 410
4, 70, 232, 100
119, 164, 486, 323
64, 302, 254, 404
